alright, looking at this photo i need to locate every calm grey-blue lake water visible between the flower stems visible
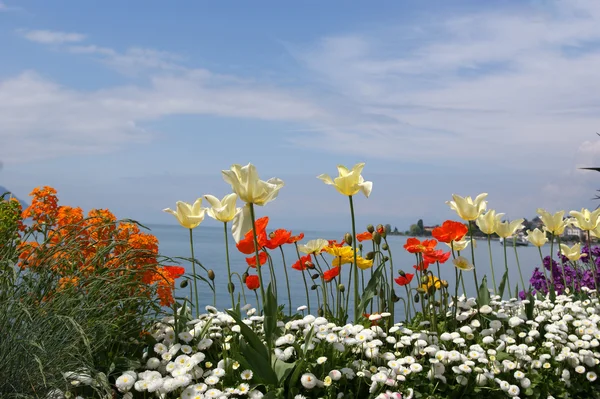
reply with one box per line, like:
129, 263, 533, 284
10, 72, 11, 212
148, 225, 556, 317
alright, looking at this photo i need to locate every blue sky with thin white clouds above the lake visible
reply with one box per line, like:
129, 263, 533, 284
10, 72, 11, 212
0, 0, 600, 229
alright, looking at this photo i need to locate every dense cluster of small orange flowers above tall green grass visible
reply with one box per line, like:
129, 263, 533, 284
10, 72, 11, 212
19, 187, 184, 306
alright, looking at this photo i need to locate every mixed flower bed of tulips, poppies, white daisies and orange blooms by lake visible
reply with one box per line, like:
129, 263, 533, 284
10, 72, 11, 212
0, 164, 600, 399
